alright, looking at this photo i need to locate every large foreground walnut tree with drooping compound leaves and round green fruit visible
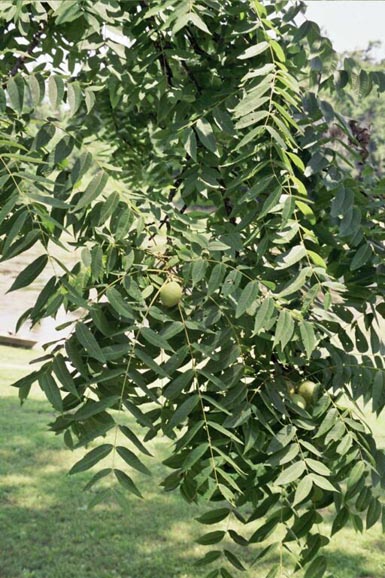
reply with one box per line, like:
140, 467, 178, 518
0, 0, 385, 578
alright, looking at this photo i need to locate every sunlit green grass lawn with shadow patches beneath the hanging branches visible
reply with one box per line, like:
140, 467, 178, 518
0, 347, 385, 578
